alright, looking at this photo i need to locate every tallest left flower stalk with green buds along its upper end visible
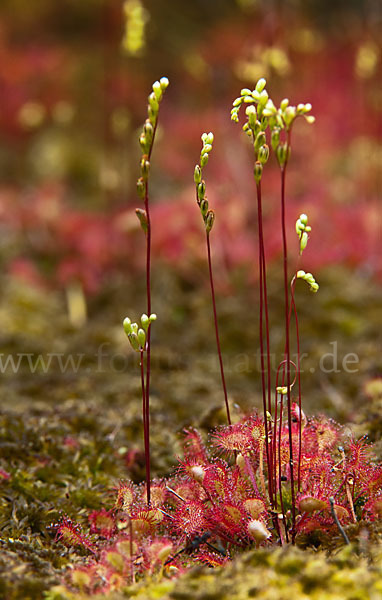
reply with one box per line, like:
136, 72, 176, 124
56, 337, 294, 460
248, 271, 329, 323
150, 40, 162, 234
136, 77, 169, 504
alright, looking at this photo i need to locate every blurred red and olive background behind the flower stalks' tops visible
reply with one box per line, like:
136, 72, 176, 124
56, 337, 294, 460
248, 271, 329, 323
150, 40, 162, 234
0, 0, 382, 294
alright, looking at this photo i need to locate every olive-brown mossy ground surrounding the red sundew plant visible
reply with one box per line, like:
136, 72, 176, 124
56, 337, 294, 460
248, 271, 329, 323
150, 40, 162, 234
0, 269, 382, 600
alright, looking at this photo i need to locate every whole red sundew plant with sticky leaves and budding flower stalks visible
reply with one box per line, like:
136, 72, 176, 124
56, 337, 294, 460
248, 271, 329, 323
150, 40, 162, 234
51, 77, 382, 597
